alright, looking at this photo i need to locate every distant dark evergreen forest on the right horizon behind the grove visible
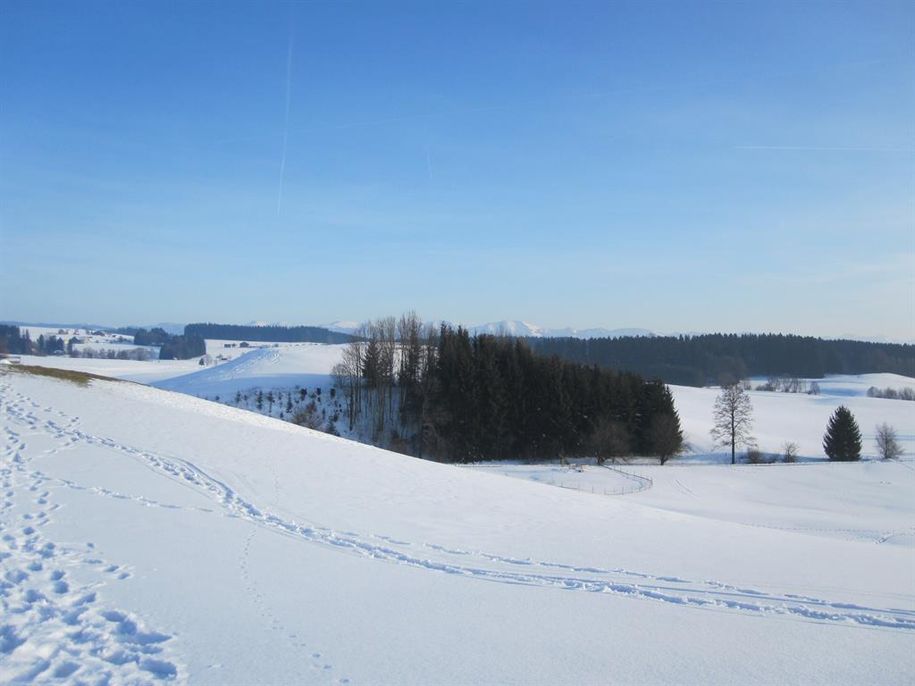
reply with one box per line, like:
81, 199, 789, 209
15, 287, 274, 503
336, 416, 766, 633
528, 334, 915, 386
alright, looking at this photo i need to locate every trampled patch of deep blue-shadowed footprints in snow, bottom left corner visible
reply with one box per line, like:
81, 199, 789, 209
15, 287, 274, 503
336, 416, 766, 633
0, 384, 185, 686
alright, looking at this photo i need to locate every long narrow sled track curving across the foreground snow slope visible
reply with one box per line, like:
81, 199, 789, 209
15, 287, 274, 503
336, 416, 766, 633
0, 378, 915, 643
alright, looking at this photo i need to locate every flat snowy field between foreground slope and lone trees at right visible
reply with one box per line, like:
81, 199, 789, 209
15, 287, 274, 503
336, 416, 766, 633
468, 457, 915, 548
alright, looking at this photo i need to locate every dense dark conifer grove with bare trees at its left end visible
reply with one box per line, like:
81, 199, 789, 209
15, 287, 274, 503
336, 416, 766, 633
334, 313, 683, 462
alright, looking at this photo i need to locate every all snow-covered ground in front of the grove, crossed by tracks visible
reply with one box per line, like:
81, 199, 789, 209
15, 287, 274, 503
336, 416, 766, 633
0, 368, 915, 684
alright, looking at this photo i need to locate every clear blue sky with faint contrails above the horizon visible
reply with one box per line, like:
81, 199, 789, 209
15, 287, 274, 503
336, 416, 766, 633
0, 0, 915, 339
